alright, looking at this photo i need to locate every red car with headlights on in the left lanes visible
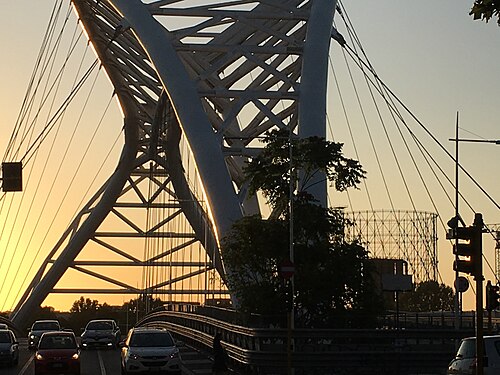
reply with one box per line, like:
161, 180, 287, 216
35, 332, 80, 375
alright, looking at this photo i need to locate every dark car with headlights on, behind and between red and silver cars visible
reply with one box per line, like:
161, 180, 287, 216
81, 319, 121, 349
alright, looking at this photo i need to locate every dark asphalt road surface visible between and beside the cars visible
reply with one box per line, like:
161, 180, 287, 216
0, 339, 211, 375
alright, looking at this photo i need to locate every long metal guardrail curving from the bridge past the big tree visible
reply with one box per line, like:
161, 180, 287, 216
139, 311, 474, 375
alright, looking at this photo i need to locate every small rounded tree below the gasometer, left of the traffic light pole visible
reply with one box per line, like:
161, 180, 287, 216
399, 280, 453, 312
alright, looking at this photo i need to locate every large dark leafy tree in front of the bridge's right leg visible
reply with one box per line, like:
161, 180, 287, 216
222, 131, 381, 327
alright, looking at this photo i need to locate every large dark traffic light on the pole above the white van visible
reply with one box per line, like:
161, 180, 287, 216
446, 215, 483, 277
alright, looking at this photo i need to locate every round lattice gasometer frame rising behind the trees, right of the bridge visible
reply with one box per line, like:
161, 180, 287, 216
344, 210, 438, 283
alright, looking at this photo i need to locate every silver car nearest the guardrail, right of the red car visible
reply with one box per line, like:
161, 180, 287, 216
121, 328, 182, 375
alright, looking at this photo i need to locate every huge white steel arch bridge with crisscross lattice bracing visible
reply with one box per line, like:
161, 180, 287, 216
12, 0, 336, 325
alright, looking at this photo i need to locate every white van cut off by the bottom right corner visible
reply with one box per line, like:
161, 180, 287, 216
446, 335, 500, 375
